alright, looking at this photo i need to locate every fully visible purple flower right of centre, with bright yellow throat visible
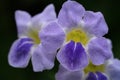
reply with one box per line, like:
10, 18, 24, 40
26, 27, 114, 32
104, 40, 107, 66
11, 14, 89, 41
57, 0, 112, 71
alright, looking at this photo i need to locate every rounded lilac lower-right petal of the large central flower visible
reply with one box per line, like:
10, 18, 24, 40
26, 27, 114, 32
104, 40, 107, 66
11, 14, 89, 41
88, 37, 113, 65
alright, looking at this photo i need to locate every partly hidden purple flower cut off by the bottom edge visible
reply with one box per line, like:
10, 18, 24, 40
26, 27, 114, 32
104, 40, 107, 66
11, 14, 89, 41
55, 58, 120, 80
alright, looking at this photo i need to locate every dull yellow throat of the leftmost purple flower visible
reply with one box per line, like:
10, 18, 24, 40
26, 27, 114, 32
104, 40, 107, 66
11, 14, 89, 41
27, 28, 40, 44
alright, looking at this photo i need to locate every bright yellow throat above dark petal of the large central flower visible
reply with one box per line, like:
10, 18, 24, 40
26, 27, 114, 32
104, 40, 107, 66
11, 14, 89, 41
66, 28, 89, 45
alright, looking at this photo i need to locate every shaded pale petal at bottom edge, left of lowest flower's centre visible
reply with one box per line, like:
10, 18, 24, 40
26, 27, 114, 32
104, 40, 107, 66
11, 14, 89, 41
55, 65, 84, 80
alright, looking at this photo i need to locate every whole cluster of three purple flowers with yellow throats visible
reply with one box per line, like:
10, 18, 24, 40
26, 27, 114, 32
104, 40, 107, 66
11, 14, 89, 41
8, 0, 120, 80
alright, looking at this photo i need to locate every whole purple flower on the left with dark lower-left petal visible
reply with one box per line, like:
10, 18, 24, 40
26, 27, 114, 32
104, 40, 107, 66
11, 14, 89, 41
8, 4, 65, 72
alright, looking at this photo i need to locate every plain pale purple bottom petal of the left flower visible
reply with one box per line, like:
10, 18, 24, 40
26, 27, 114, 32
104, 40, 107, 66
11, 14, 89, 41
32, 45, 55, 72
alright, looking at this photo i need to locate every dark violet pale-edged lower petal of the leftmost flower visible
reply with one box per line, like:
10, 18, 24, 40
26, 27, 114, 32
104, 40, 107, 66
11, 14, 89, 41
8, 38, 33, 68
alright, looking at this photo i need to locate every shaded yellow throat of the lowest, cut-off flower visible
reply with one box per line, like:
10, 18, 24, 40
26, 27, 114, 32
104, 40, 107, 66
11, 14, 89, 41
84, 62, 105, 74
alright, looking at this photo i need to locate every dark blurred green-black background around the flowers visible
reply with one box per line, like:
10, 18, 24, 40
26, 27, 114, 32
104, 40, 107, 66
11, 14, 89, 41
0, 0, 120, 80
